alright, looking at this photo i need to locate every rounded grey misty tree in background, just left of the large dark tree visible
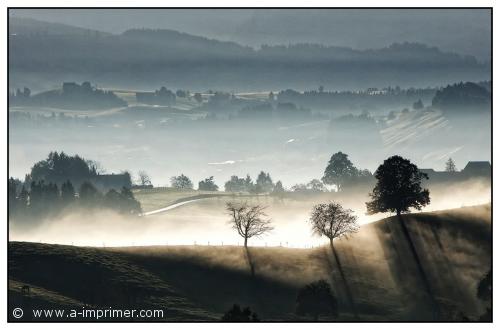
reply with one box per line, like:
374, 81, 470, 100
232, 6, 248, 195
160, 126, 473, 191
321, 151, 357, 190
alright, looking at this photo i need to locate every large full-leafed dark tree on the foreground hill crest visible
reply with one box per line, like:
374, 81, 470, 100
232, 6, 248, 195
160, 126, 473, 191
366, 156, 430, 216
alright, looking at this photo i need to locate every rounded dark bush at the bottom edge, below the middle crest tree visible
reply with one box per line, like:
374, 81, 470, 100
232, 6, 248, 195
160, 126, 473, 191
295, 280, 338, 321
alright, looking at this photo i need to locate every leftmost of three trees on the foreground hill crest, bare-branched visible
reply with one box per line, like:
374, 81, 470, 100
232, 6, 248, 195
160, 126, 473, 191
226, 203, 273, 248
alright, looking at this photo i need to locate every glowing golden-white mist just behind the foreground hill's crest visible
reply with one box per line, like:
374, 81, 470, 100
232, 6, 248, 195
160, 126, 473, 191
9, 180, 491, 248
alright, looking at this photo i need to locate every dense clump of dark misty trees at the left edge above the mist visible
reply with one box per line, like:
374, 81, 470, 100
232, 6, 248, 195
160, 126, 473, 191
8, 152, 141, 222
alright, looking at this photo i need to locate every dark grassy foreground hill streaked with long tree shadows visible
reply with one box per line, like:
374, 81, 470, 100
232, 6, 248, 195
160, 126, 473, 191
9, 205, 492, 321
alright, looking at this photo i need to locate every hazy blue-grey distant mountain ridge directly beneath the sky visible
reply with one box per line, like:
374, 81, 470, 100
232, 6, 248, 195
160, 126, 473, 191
9, 17, 491, 91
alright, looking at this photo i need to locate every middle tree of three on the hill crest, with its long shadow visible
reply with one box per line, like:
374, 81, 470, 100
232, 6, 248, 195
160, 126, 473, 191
310, 202, 359, 317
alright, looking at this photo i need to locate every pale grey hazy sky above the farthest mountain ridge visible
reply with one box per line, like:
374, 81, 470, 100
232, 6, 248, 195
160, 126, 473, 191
10, 9, 491, 59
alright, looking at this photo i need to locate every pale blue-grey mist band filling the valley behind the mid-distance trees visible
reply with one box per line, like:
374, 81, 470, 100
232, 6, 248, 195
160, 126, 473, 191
9, 109, 491, 188
